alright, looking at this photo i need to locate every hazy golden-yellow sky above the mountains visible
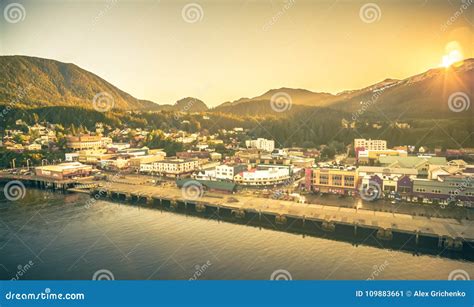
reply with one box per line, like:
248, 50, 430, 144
0, 0, 474, 106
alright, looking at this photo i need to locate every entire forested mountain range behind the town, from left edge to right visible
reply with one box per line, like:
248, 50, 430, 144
0, 56, 474, 117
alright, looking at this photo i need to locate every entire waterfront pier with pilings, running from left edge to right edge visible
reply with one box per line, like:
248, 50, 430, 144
0, 174, 474, 251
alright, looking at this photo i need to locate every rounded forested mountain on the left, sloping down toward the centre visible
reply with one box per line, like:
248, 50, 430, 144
0, 55, 161, 110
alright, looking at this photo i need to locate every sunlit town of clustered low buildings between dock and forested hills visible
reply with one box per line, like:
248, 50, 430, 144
1, 120, 474, 211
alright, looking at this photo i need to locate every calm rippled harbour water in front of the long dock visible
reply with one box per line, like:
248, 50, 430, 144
0, 189, 474, 279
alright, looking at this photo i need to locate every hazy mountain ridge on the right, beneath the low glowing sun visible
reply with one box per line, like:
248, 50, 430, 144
213, 58, 474, 118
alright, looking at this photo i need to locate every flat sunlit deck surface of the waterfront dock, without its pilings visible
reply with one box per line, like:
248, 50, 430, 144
99, 182, 474, 242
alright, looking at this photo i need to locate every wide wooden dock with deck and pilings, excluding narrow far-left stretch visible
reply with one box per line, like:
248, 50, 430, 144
91, 182, 474, 250
